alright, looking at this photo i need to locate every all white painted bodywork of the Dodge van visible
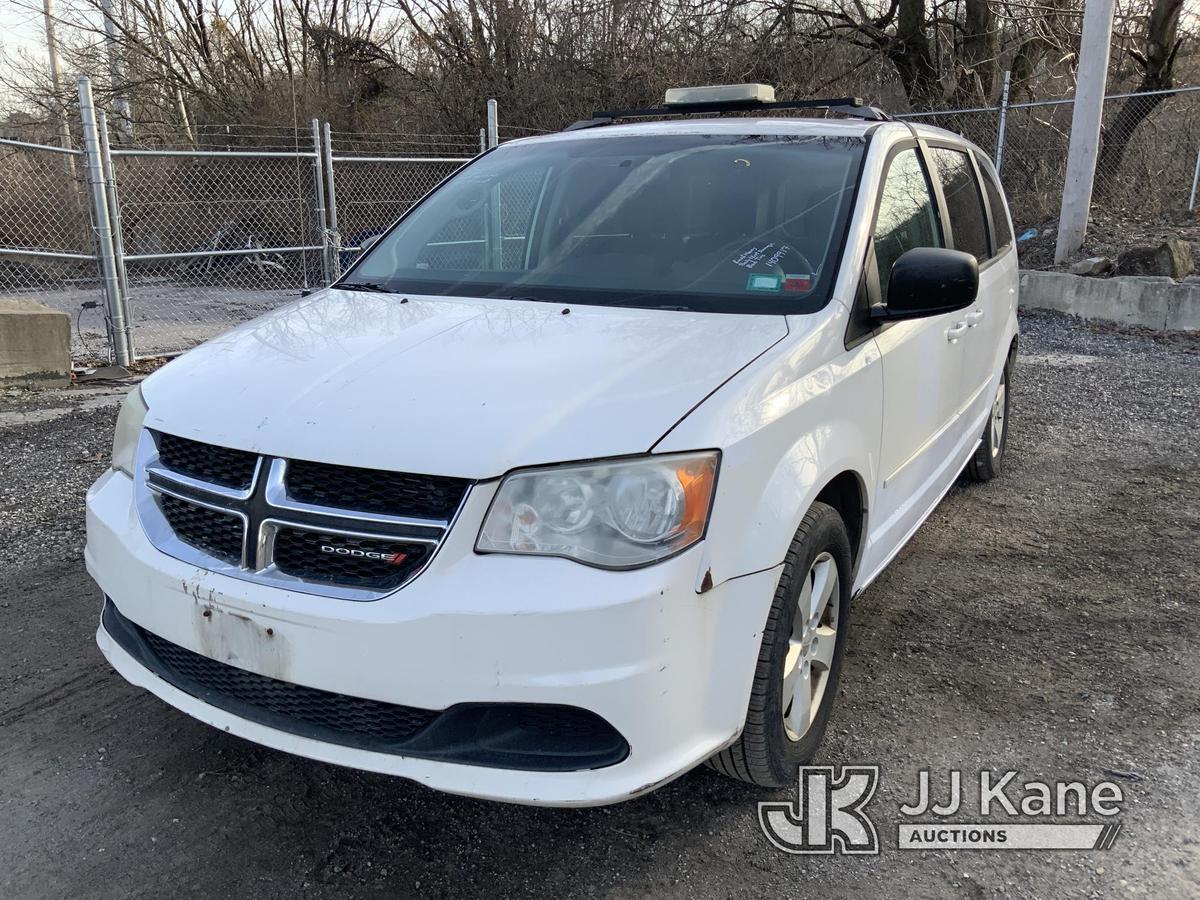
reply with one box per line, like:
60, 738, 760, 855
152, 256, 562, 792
86, 119, 1016, 805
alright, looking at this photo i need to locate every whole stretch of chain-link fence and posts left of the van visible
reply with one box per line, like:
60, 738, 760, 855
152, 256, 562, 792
0, 84, 479, 362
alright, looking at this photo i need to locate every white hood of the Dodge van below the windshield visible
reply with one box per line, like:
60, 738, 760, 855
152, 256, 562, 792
143, 289, 787, 479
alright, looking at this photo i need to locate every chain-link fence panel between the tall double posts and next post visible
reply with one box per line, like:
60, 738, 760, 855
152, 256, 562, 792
113, 150, 325, 355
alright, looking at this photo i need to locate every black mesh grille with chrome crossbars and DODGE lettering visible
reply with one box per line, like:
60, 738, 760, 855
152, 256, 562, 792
137, 430, 470, 600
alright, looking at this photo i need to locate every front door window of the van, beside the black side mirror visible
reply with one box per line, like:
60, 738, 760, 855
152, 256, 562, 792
875, 149, 944, 302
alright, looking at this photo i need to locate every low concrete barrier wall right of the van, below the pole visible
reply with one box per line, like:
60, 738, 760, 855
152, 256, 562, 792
1020, 271, 1200, 331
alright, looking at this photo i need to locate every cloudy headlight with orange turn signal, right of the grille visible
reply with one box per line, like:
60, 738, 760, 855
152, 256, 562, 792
475, 451, 720, 569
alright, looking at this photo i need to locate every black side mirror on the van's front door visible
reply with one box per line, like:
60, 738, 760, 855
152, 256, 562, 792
871, 247, 979, 322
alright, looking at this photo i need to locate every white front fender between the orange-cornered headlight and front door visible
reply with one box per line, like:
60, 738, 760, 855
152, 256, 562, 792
654, 304, 883, 589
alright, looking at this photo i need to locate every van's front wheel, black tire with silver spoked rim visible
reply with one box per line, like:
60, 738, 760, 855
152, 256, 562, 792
708, 503, 851, 787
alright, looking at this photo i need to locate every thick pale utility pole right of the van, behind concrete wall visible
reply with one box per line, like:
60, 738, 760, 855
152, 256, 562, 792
1054, 0, 1114, 263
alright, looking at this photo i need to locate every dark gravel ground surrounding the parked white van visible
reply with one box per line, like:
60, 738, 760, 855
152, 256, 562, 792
0, 314, 1200, 898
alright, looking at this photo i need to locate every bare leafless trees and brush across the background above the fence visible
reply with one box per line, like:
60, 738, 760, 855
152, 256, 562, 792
0, 0, 1186, 142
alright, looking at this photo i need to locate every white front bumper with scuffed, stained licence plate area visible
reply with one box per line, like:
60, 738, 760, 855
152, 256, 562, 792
85, 472, 779, 805
